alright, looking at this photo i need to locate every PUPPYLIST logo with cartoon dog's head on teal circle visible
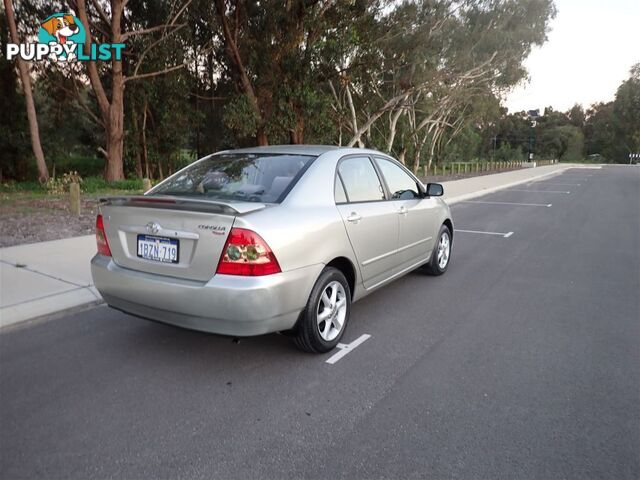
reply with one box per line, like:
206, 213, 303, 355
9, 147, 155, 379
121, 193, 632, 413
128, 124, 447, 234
5, 12, 124, 62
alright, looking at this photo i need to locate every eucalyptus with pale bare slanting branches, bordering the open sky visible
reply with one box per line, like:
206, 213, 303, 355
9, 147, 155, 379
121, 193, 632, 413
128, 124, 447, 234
344, 0, 555, 170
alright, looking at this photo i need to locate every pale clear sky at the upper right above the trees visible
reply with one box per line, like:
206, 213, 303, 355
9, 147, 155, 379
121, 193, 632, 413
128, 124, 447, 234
504, 0, 640, 113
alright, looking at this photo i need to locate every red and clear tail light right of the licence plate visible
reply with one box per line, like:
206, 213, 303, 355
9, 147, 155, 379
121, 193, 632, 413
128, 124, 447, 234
216, 228, 281, 277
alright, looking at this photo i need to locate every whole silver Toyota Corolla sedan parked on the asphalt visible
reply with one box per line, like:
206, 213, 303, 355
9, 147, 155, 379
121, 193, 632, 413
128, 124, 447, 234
91, 145, 453, 352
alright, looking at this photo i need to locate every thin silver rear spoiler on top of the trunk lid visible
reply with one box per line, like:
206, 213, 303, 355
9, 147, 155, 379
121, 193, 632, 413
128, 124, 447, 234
100, 195, 266, 215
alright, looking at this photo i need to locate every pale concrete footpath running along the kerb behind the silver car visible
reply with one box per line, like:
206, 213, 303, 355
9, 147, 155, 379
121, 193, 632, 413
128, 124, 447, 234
0, 164, 592, 329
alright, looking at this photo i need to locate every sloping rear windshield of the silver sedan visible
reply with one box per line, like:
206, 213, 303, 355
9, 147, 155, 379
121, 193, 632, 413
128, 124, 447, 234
151, 153, 316, 203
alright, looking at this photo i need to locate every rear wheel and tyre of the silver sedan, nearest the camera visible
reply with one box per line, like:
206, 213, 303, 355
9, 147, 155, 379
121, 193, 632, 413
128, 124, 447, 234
294, 267, 351, 353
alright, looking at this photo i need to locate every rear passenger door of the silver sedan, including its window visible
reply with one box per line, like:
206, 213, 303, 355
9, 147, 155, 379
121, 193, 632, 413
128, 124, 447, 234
335, 156, 399, 288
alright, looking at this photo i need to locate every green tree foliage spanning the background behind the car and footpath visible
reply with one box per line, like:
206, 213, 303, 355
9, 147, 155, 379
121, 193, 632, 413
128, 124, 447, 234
0, 0, 640, 182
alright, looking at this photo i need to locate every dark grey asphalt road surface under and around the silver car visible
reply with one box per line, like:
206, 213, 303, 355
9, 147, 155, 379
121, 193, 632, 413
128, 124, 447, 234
0, 167, 640, 479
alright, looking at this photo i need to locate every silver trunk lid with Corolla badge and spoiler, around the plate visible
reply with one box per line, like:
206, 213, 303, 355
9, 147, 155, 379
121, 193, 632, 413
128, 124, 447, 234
100, 196, 265, 281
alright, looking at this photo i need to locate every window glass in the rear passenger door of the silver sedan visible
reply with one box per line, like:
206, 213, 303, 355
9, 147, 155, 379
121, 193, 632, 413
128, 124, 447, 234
336, 157, 384, 202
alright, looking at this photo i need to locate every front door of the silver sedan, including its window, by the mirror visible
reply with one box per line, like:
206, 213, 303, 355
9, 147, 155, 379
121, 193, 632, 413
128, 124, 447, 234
375, 157, 437, 269
